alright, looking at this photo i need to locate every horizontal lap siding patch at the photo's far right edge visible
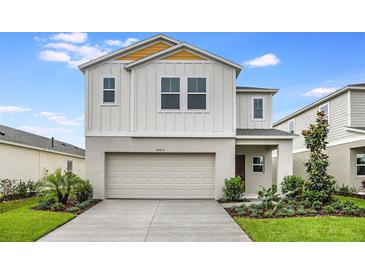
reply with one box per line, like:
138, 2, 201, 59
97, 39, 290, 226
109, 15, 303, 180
351, 90, 365, 127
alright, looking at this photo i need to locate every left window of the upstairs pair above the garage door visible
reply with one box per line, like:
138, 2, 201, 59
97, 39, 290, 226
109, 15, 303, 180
161, 77, 180, 109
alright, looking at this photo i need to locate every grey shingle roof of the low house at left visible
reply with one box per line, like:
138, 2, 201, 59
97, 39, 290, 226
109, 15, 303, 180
0, 125, 85, 157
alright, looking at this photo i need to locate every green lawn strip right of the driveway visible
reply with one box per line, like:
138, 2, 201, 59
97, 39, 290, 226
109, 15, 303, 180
235, 216, 365, 242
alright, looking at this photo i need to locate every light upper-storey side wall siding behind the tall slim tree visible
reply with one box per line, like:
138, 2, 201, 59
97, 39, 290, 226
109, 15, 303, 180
275, 92, 353, 150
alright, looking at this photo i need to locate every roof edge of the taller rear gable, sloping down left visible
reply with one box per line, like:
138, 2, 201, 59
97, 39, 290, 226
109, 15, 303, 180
78, 34, 180, 72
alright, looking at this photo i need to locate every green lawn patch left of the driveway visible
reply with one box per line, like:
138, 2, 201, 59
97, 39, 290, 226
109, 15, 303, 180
0, 198, 75, 242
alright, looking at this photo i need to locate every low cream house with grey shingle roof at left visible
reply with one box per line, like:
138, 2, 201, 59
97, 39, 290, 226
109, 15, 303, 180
0, 125, 85, 180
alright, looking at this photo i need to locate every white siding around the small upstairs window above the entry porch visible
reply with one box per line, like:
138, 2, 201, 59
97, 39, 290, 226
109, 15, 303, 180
236, 93, 272, 128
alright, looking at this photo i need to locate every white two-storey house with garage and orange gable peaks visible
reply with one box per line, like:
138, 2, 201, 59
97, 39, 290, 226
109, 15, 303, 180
79, 35, 294, 199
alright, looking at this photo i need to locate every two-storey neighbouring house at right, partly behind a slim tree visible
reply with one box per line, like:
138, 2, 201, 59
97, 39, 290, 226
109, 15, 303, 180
274, 84, 365, 188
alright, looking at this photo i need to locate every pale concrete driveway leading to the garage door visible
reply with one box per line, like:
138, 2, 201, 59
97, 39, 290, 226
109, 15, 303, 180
39, 200, 250, 242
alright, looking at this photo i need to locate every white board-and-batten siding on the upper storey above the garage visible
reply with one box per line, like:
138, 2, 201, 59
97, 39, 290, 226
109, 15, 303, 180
85, 60, 236, 135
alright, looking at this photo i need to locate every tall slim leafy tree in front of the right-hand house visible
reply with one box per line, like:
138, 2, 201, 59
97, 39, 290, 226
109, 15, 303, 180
302, 112, 335, 204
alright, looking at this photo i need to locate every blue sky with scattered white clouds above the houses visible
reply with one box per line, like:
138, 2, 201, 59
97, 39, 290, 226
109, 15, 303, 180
0, 33, 365, 147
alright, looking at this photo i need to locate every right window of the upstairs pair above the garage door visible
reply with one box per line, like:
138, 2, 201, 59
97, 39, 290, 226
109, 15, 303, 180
188, 77, 207, 110
